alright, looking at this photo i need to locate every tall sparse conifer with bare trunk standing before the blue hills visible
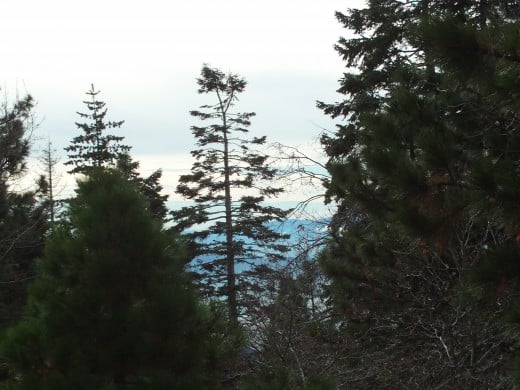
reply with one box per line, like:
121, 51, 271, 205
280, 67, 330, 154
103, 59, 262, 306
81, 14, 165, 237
172, 66, 287, 323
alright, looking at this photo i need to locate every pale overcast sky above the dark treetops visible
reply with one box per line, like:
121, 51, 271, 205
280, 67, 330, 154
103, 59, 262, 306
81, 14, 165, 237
0, 0, 363, 207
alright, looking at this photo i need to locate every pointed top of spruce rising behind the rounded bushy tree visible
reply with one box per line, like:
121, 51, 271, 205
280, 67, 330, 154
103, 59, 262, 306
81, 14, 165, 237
65, 84, 130, 174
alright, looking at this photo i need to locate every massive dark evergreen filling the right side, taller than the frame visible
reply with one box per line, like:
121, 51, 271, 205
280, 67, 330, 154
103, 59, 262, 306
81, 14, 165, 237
319, 1, 520, 388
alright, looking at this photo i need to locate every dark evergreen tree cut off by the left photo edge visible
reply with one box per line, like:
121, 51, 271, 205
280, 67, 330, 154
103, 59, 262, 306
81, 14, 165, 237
0, 96, 48, 328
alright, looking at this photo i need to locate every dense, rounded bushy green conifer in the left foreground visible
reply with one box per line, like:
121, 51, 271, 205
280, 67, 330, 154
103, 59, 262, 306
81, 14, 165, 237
1, 170, 236, 389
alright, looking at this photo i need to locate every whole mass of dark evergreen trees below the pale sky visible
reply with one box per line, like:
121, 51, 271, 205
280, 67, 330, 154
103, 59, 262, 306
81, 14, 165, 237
0, 0, 520, 389
